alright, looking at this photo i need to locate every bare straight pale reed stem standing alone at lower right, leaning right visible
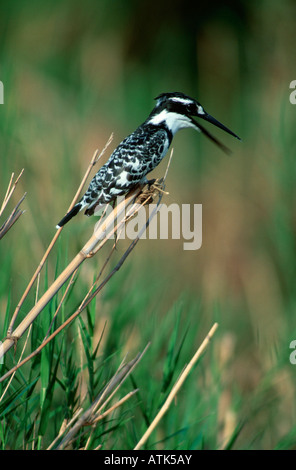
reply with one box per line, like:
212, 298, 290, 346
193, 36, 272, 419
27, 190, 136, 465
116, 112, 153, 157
134, 323, 218, 450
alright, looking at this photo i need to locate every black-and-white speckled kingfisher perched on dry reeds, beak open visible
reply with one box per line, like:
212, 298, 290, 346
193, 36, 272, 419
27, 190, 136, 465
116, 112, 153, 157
57, 92, 240, 228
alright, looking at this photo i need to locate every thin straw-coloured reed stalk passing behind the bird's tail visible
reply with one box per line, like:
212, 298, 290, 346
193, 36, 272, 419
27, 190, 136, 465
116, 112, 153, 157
7, 134, 113, 336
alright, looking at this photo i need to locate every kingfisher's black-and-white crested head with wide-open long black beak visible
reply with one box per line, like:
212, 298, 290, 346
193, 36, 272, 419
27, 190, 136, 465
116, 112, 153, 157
147, 92, 241, 152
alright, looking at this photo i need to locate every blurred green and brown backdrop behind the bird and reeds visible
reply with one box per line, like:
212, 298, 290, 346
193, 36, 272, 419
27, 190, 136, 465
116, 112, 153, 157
0, 0, 296, 448
